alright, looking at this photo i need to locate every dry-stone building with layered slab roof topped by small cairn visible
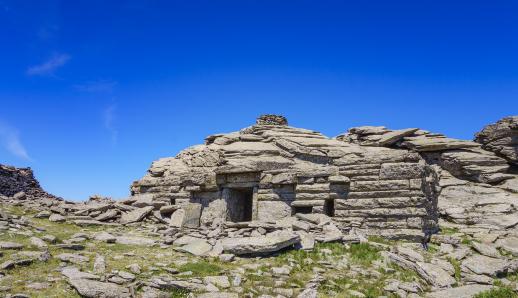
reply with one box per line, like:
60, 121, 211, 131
132, 115, 452, 237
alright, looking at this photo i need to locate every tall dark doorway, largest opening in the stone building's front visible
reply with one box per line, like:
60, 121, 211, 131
227, 187, 254, 222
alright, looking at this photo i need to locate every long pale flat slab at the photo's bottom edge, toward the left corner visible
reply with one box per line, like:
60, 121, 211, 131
68, 279, 131, 298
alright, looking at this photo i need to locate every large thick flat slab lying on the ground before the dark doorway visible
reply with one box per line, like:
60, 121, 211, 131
221, 233, 300, 255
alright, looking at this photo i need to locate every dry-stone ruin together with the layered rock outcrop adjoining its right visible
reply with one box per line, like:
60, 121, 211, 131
126, 115, 518, 240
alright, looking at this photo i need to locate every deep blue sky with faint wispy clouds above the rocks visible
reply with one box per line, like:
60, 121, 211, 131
0, 0, 518, 200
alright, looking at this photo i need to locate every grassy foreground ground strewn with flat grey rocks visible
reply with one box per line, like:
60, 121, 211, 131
0, 205, 518, 298
